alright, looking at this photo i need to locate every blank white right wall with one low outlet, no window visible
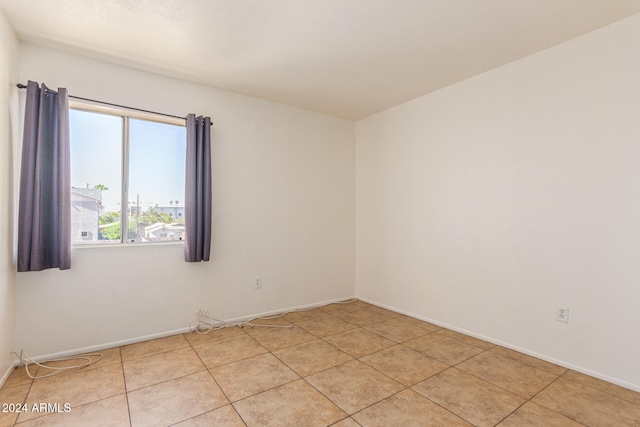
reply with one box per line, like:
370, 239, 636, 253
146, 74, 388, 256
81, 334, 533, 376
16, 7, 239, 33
356, 15, 640, 390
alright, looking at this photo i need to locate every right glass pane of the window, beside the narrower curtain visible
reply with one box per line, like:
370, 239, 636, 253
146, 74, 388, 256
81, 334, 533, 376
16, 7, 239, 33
127, 119, 186, 242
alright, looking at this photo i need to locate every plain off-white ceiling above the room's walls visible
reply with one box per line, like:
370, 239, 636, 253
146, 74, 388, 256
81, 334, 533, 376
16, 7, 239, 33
0, 0, 640, 120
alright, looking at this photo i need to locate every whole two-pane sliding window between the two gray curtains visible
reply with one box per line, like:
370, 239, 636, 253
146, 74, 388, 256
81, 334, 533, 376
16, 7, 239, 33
69, 102, 186, 244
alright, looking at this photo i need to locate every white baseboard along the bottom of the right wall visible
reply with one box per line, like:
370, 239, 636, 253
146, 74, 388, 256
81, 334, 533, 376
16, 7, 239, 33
357, 297, 640, 392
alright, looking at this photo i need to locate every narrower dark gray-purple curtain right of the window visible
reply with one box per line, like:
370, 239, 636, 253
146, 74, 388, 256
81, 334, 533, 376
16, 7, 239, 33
184, 114, 211, 262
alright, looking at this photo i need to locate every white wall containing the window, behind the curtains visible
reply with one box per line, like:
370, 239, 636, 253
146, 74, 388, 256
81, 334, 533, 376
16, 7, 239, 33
16, 44, 355, 356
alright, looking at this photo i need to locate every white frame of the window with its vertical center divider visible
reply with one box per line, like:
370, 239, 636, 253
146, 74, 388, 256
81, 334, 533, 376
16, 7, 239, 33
69, 99, 186, 247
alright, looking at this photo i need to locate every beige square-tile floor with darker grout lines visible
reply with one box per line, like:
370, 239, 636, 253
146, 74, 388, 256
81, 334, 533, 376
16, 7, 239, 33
0, 301, 640, 427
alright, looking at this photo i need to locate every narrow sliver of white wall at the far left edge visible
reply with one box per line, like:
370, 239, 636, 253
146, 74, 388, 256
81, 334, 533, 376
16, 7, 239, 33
0, 11, 18, 384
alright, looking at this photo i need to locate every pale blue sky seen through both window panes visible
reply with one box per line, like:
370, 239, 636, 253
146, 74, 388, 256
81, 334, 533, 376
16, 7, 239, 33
70, 110, 186, 210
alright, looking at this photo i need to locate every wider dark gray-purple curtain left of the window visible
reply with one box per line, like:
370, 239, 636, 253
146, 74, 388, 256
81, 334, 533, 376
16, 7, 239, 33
18, 81, 71, 271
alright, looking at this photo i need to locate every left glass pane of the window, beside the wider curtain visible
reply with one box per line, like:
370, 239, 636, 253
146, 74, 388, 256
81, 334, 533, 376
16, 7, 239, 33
69, 110, 122, 243
